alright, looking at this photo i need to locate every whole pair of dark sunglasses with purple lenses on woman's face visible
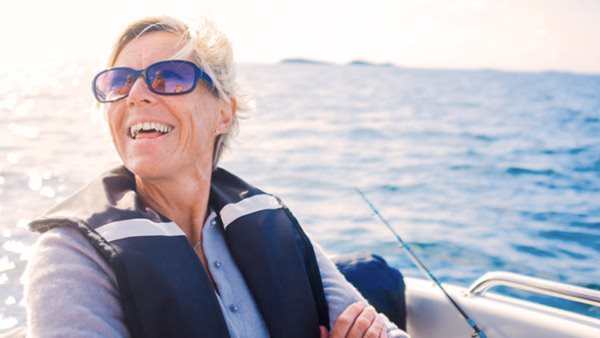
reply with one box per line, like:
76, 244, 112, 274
92, 60, 216, 103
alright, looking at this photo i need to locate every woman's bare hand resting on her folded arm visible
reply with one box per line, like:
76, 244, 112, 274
320, 302, 387, 338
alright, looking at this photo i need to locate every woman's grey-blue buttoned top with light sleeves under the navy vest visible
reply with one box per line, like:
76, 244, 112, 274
25, 213, 407, 338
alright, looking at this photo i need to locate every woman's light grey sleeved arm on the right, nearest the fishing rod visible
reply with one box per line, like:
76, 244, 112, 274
311, 240, 408, 338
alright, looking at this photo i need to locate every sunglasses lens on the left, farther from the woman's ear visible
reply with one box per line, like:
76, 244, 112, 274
94, 68, 134, 102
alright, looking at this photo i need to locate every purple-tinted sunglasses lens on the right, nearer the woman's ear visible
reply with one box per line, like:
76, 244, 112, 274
147, 61, 196, 94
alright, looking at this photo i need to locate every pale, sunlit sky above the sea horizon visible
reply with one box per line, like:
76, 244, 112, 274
0, 0, 600, 74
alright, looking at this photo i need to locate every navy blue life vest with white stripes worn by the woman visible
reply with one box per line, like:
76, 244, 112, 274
30, 166, 329, 338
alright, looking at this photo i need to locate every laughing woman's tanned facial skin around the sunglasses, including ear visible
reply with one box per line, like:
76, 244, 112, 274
107, 32, 233, 179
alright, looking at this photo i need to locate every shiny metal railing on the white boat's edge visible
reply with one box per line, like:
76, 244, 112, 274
465, 271, 600, 307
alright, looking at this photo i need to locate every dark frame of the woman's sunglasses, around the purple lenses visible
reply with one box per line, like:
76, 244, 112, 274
92, 60, 218, 103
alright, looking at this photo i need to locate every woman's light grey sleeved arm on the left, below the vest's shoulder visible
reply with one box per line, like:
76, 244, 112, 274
25, 228, 129, 337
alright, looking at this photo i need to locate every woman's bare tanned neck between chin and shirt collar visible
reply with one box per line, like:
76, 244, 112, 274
135, 167, 212, 244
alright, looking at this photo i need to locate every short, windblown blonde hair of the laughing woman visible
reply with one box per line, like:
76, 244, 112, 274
108, 16, 254, 168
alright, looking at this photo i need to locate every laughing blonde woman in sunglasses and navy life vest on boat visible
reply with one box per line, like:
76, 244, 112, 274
25, 17, 405, 337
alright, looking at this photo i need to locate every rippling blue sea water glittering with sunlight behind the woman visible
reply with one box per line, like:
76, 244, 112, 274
0, 61, 600, 332
